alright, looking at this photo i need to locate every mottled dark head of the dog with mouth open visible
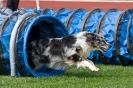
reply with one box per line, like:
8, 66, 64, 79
84, 32, 110, 52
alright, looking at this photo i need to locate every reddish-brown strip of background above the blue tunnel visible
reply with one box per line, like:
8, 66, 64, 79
0, 0, 133, 11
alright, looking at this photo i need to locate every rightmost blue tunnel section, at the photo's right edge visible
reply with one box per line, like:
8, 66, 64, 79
114, 9, 133, 66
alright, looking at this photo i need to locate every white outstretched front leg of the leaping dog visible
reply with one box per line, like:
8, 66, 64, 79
77, 59, 99, 72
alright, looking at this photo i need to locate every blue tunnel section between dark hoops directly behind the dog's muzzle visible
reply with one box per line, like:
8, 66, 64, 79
97, 9, 121, 64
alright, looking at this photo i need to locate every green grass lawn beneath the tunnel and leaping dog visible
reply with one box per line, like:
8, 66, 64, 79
0, 65, 133, 88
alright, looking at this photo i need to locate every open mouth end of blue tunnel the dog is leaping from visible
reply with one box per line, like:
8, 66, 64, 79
0, 7, 68, 77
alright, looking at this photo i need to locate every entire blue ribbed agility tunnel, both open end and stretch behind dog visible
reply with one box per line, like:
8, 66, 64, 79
0, 8, 133, 77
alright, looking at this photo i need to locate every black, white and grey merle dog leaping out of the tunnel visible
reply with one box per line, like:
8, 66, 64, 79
27, 32, 109, 71
